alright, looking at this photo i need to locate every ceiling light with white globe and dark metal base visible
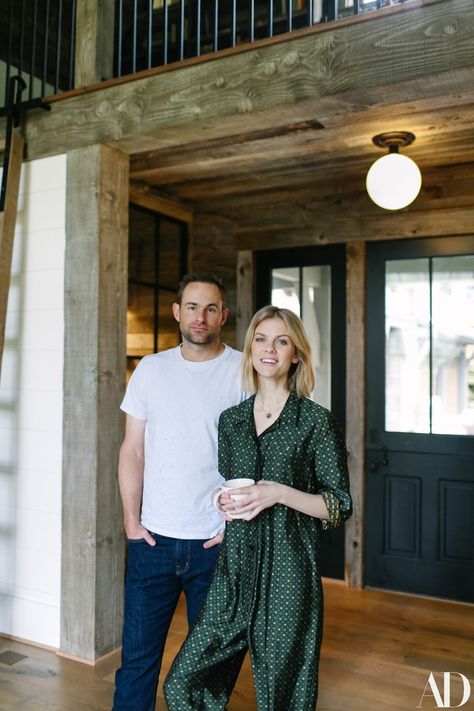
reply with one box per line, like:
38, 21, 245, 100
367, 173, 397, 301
365, 131, 421, 210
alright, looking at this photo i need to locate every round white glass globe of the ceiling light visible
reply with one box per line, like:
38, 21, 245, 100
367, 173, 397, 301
365, 153, 421, 210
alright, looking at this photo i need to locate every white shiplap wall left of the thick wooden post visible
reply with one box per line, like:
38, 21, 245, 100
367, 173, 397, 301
0, 155, 66, 647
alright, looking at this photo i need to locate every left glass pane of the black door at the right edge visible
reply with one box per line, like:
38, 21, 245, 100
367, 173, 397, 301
385, 259, 430, 432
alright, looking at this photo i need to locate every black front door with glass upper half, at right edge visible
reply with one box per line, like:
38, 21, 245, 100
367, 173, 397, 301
366, 238, 474, 601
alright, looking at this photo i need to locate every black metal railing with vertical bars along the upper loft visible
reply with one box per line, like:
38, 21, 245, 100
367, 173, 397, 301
0, 0, 412, 111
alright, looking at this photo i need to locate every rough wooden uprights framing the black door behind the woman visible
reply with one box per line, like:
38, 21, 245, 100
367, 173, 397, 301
237, 242, 366, 588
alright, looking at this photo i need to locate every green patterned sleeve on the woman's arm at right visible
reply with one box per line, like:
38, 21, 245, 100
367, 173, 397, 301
314, 412, 352, 530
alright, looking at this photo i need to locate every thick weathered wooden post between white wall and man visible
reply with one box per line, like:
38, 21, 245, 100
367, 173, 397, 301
60, 145, 129, 660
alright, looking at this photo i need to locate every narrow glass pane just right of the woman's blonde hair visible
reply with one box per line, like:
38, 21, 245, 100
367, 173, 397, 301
303, 265, 331, 409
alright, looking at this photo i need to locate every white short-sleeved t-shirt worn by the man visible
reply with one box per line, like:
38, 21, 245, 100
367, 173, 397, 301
121, 346, 245, 539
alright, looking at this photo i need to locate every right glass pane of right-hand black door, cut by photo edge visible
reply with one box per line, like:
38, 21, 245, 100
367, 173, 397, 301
432, 255, 474, 435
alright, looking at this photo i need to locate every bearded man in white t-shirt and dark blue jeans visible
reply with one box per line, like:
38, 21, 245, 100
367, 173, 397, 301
113, 274, 243, 711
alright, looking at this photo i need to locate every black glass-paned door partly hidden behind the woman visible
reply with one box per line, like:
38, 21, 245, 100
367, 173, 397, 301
255, 245, 346, 579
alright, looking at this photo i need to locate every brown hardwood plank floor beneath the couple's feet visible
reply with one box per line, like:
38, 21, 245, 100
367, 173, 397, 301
0, 581, 474, 711
